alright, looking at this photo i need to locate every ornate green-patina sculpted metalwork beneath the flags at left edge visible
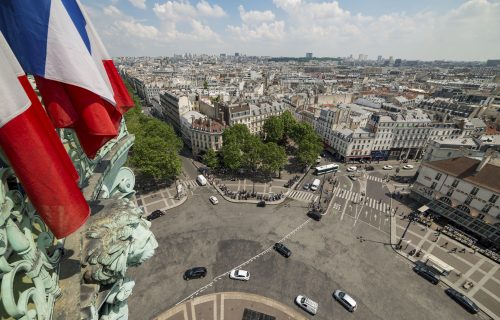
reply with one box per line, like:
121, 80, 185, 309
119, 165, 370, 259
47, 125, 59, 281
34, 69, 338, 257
0, 122, 158, 320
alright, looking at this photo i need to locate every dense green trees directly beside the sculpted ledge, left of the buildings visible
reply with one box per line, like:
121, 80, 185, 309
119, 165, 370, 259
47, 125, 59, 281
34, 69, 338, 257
125, 86, 182, 181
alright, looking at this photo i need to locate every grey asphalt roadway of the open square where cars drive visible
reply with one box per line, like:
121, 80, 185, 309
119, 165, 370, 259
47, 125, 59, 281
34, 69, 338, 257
128, 172, 476, 320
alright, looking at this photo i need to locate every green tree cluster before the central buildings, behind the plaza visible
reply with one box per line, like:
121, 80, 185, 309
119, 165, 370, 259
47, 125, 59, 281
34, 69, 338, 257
203, 111, 323, 174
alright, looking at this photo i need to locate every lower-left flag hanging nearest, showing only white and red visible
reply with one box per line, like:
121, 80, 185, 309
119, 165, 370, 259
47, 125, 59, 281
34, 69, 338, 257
0, 32, 90, 238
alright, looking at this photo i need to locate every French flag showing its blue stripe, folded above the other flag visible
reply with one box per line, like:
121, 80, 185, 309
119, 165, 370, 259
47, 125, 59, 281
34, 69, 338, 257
0, 0, 133, 158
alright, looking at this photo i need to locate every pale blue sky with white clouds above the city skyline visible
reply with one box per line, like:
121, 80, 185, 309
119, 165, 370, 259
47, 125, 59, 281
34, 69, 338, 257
81, 0, 500, 60
